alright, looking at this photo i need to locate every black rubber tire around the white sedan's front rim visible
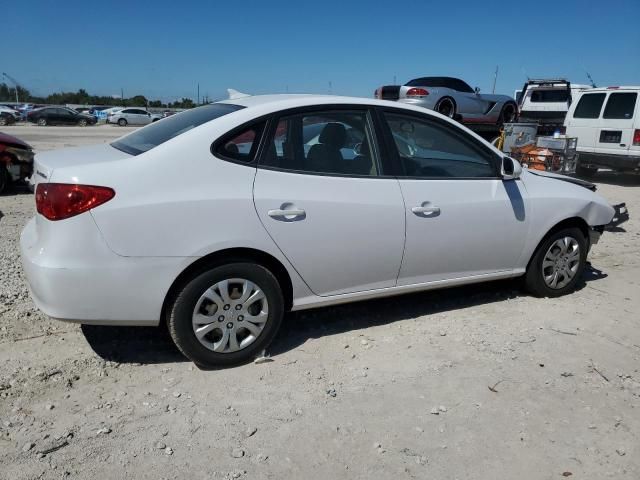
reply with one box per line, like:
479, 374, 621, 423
524, 227, 588, 297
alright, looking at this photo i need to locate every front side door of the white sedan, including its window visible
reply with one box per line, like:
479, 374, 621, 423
381, 110, 529, 285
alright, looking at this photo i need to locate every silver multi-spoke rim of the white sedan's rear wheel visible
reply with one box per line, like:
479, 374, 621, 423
192, 278, 269, 353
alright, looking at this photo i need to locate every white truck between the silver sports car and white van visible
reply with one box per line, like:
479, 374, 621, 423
517, 78, 591, 135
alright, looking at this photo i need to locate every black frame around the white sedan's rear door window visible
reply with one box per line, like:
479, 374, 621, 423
252, 103, 388, 180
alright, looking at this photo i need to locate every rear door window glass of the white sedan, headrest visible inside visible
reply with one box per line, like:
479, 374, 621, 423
262, 111, 378, 176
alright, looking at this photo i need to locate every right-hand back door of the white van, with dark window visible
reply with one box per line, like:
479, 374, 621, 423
594, 92, 638, 155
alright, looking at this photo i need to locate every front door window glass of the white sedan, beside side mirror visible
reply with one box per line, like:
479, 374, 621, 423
384, 113, 496, 178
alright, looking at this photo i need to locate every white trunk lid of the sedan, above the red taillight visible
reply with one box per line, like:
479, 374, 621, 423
34, 143, 131, 183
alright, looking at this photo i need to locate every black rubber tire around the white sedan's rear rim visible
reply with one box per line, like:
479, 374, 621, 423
167, 263, 284, 367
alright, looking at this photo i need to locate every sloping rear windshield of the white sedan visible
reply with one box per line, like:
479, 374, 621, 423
111, 103, 245, 155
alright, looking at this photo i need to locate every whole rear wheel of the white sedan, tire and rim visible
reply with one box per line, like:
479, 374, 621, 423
167, 263, 284, 367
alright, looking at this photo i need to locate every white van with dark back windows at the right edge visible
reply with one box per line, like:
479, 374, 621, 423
564, 87, 640, 176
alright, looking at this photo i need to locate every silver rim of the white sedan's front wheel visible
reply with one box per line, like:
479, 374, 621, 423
542, 236, 580, 290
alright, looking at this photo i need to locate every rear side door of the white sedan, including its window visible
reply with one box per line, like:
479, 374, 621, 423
254, 106, 405, 296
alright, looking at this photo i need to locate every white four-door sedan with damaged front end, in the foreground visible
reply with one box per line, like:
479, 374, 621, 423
21, 95, 614, 365
